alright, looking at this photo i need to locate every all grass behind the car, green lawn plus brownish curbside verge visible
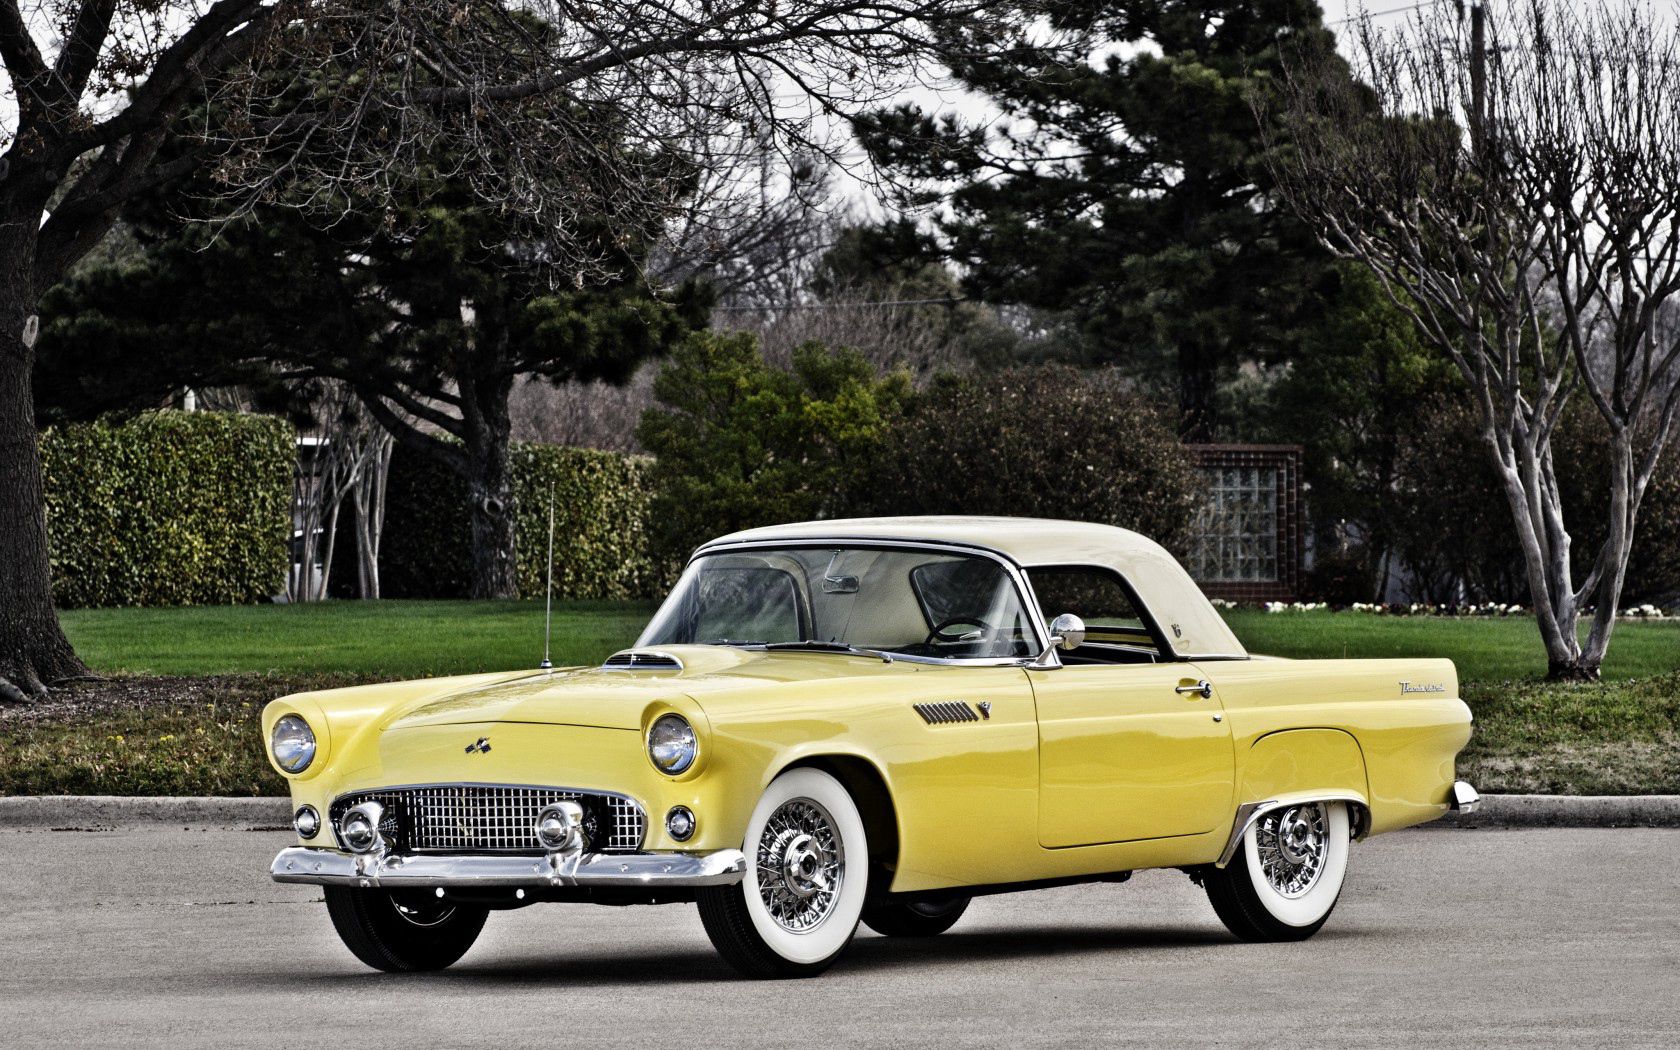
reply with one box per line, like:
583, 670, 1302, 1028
13, 601, 1680, 795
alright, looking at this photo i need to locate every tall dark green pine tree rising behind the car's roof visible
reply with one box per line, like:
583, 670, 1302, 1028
860, 0, 1334, 438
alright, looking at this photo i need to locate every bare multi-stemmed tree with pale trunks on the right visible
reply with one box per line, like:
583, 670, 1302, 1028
1272, 0, 1680, 679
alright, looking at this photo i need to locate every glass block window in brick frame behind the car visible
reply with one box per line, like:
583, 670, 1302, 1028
1189, 465, 1280, 583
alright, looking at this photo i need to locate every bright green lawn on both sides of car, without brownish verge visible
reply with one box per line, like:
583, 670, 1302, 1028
62, 601, 1680, 682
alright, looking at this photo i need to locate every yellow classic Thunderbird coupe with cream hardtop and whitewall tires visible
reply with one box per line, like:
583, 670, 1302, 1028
264, 517, 1477, 976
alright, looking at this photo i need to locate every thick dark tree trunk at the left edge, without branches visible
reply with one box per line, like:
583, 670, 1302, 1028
0, 273, 87, 702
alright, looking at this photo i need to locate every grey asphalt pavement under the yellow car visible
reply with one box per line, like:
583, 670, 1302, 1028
0, 825, 1680, 1050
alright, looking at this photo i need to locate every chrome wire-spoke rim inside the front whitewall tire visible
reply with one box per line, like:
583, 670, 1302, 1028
756, 798, 845, 934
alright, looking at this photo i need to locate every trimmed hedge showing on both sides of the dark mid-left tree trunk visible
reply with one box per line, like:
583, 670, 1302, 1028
381, 442, 669, 598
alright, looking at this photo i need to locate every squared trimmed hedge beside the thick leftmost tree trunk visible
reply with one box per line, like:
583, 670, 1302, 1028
40, 412, 294, 608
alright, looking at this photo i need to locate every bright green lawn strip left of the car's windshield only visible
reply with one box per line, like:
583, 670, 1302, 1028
60, 601, 654, 679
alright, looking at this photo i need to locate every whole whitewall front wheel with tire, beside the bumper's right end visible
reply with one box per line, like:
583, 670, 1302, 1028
699, 769, 869, 978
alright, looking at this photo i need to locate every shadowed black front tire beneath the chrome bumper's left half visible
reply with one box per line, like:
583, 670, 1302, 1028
326, 885, 489, 973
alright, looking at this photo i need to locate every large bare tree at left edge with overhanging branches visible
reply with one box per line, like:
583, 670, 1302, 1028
0, 0, 1008, 701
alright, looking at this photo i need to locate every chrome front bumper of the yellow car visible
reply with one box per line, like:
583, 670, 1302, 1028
269, 847, 746, 889
